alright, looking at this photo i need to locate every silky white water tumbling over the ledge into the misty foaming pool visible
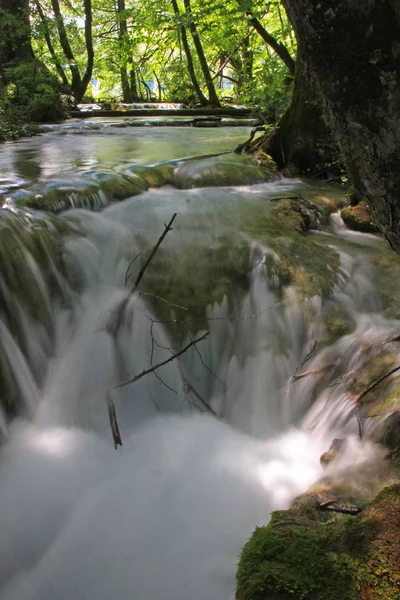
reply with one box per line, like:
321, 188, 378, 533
0, 123, 400, 600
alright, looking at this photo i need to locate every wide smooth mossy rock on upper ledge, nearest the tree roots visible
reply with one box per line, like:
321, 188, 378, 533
175, 154, 273, 189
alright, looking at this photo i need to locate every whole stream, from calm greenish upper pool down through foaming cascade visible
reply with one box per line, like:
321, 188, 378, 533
0, 120, 400, 600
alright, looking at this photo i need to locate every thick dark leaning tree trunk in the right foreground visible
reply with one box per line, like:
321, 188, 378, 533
283, 0, 400, 253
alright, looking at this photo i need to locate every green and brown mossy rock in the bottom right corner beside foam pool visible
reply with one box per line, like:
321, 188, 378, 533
236, 485, 400, 600
